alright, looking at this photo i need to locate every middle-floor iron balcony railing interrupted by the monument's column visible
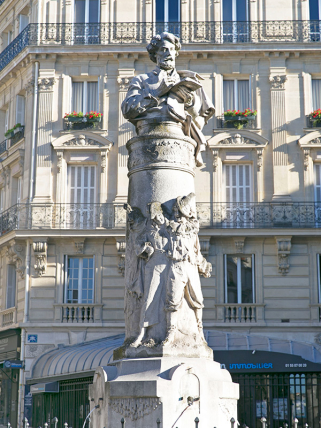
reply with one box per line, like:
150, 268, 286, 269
0, 202, 321, 235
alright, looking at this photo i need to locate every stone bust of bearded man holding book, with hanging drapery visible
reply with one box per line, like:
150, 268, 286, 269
122, 32, 215, 166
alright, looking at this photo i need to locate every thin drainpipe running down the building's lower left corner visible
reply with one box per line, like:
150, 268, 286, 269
17, 239, 31, 428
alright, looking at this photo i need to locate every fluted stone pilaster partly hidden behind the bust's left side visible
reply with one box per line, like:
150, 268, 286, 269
115, 75, 134, 202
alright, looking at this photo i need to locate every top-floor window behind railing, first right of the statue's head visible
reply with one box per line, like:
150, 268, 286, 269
222, 0, 249, 43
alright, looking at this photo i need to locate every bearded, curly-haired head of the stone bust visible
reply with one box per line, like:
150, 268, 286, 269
146, 32, 181, 70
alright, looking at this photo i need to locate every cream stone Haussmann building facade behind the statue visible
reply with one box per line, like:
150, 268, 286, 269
0, 0, 321, 428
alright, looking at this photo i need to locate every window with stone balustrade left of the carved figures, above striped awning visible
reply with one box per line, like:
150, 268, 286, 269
65, 256, 94, 304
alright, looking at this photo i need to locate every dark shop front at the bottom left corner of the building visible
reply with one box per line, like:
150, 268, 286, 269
0, 329, 22, 428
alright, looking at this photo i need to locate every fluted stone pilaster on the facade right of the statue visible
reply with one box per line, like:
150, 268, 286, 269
269, 75, 291, 201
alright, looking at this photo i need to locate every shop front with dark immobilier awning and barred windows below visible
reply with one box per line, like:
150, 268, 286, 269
215, 350, 321, 428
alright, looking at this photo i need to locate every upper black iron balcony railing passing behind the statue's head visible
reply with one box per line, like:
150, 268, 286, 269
0, 20, 321, 70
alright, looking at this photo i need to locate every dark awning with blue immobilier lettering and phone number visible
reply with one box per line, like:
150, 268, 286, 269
214, 351, 321, 373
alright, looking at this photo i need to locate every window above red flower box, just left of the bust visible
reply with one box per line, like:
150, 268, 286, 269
72, 82, 98, 114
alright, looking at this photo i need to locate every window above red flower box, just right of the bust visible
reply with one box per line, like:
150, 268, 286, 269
223, 79, 252, 111
